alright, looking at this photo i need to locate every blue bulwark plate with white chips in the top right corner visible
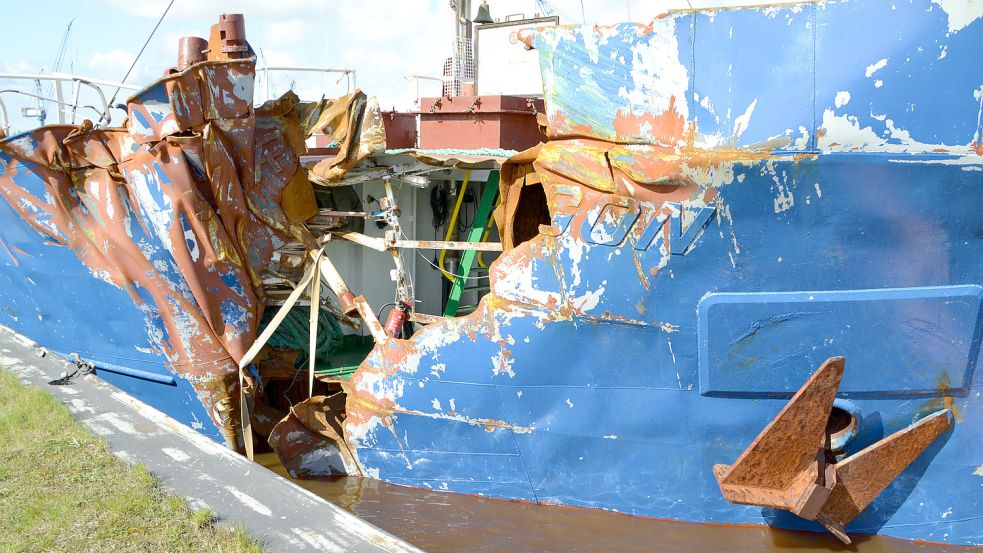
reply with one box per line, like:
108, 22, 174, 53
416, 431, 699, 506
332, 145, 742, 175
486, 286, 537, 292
816, 0, 983, 151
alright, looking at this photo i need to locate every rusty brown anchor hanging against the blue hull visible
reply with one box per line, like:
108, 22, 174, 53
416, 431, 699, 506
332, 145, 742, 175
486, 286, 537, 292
713, 357, 952, 543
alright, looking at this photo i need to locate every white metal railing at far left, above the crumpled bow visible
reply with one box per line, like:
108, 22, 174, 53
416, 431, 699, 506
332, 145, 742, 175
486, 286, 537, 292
0, 73, 140, 134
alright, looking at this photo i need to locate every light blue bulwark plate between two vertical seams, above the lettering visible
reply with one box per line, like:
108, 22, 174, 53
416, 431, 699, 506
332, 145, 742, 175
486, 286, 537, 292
677, 4, 816, 150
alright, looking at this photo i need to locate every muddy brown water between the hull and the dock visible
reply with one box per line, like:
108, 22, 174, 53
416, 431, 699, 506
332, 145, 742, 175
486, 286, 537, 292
256, 453, 980, 553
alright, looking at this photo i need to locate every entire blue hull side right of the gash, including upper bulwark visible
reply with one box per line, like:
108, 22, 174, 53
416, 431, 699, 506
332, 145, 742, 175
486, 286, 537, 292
345, 0, 983, 544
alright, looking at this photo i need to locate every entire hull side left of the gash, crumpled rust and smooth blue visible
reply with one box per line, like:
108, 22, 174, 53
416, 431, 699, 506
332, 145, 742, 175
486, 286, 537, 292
0, 25, 364, 448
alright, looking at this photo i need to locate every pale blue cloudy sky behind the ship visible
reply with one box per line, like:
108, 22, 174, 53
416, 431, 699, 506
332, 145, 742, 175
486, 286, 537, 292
0, 0, 746, 131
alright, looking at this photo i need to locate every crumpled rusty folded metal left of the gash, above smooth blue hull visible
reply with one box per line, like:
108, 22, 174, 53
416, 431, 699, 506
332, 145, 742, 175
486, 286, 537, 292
0, 12, 381, 447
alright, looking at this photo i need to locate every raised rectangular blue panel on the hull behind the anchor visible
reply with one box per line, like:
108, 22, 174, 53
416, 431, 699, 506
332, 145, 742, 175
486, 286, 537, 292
698, 286, 983, 396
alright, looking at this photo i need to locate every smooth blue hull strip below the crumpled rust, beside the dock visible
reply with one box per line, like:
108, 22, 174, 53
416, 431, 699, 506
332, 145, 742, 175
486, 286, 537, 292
0, 175, 225, 443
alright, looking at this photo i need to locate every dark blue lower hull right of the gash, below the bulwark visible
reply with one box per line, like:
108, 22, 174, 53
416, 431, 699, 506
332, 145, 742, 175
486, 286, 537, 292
349, 155, 983, 544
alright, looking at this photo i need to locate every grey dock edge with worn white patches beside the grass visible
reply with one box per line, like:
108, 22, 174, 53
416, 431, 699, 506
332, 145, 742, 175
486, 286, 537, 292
0, 326, 421, 553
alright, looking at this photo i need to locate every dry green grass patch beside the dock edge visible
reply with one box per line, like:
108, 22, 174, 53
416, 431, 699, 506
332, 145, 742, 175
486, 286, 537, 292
0, 369, 262, 553
